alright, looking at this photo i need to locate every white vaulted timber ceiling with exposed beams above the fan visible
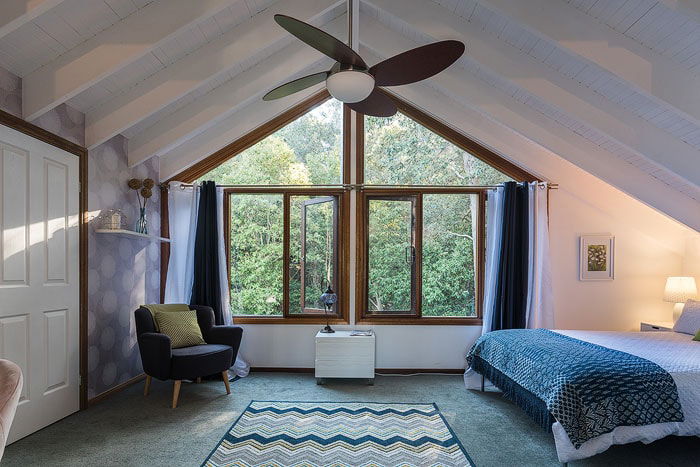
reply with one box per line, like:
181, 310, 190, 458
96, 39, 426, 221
0, 0, 700, 229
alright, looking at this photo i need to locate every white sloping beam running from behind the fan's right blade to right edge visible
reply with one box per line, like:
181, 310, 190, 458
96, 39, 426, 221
362, 0, 700, 188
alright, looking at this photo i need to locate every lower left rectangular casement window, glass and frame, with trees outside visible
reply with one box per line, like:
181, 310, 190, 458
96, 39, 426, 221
224, 187, 347, 322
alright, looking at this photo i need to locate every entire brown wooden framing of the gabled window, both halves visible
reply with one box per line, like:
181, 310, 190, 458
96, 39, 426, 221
161, 90, 539, 325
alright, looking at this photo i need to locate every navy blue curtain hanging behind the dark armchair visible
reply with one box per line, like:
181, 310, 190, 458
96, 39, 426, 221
190, 182, 224, 325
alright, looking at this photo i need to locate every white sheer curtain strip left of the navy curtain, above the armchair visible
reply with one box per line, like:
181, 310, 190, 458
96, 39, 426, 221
165, 182, 199, 303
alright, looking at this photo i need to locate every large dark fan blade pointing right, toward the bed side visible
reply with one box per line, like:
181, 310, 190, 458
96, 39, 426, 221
369, 41, 464, 86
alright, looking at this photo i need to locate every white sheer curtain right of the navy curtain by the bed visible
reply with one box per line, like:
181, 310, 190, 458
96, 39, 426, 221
525, 182, 554, 329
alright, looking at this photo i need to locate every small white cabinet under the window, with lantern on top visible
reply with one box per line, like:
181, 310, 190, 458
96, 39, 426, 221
315, 331, 375, 384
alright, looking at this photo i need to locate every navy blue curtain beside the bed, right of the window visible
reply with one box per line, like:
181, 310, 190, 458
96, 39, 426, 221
485, 182, 529, 331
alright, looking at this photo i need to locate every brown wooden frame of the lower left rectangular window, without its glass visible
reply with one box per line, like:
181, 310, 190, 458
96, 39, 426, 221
224, 186, 350, 324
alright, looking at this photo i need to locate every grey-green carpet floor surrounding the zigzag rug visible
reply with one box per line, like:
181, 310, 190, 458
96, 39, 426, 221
2, 373, 698, 467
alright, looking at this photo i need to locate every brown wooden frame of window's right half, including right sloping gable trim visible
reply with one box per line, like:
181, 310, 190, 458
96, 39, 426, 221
355, 90, 539, 326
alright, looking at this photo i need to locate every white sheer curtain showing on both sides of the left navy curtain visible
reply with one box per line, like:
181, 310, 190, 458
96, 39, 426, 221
165, 182, 250, 377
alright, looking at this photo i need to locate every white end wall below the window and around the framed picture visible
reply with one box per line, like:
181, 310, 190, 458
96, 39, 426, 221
241, 86, 700, 369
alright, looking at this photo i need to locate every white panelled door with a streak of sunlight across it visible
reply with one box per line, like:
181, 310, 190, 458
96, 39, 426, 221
0, 125, 80, 442
